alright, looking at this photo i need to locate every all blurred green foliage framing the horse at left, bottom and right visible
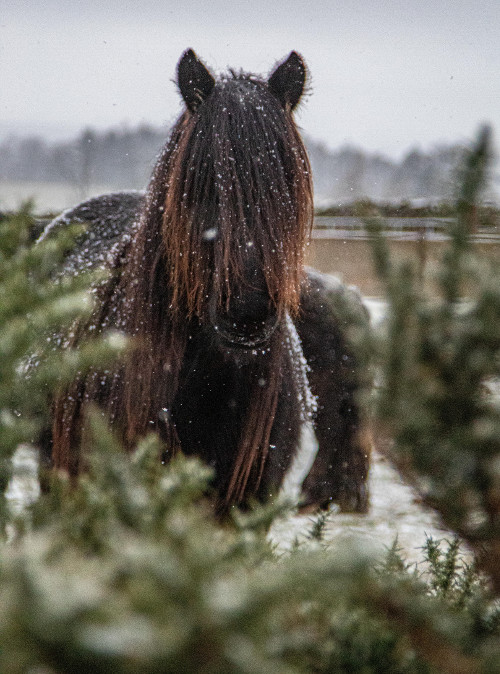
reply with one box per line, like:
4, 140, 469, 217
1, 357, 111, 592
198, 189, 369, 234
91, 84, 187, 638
0, 127, 500, 674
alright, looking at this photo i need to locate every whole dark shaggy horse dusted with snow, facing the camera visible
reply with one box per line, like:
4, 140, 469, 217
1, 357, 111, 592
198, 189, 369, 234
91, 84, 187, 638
42, 49, 369, 512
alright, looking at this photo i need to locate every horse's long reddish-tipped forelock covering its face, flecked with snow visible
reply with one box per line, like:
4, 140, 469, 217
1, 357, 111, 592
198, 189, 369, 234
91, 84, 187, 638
156, 74, 312, 318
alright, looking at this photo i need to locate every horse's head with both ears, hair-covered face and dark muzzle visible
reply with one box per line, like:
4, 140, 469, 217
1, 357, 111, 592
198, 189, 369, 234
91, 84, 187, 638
160, 50, 312, 349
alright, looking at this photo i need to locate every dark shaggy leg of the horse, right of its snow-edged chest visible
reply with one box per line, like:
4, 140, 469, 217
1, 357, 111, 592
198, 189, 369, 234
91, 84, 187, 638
297, 282, 369, 512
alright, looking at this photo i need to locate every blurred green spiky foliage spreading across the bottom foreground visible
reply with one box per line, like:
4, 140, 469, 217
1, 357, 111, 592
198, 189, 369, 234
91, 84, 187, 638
0, 413, 494, 673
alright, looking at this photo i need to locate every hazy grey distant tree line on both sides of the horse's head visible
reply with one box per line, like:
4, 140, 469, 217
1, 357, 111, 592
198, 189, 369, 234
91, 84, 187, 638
0, 125, 498, 207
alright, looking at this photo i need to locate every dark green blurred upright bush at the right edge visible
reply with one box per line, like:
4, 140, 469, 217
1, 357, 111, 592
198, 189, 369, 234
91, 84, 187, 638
370, 129, 500, 594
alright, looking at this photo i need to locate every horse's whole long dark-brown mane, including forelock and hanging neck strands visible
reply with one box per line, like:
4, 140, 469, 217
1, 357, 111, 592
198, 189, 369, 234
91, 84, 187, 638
53, 64, 312, 504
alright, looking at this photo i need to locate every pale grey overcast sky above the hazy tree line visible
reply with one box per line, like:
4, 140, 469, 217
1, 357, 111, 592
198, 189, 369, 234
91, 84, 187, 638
0, 0, 500, 157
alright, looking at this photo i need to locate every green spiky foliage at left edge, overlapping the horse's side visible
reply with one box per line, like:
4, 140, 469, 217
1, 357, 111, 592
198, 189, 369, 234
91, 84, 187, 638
0, 203, 123, 532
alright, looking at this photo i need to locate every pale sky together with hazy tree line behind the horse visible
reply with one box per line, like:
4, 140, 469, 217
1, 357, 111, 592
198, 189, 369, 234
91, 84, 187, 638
0, 0, 500, 210
